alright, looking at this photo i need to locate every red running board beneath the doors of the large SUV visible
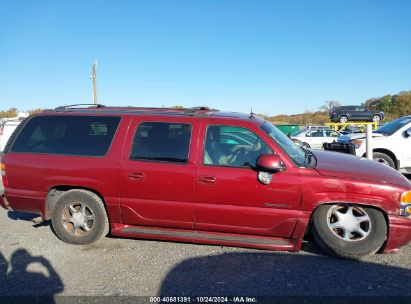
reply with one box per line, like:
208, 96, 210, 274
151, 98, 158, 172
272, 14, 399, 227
112, 225, 296, 251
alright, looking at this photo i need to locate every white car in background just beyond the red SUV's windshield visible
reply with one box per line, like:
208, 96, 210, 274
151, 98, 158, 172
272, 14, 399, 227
291, 127, 341, 149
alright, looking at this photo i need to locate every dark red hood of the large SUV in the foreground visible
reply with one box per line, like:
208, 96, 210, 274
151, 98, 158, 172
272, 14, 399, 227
310, 150, 411, 189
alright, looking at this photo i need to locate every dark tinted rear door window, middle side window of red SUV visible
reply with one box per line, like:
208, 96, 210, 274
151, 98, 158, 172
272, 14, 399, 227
130, 122, 192, 163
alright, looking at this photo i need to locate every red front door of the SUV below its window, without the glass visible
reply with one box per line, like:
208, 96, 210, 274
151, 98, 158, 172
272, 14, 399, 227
195, 122, 301, 237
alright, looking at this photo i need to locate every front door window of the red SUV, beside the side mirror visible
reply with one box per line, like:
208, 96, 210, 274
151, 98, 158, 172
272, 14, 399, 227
203, 126, 273, 167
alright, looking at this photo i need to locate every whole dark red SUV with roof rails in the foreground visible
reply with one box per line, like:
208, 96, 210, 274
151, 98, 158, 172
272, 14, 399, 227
0, 106, 411, 257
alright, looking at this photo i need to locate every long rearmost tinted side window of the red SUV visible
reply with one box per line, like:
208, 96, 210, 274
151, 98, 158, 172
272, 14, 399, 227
11, 116, 120, 156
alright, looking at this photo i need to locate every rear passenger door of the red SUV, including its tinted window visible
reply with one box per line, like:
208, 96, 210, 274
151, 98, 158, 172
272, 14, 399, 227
121, 118, 199, 229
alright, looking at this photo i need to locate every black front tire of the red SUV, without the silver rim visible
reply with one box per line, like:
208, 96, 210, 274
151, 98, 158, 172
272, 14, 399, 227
311, 205, 387, 259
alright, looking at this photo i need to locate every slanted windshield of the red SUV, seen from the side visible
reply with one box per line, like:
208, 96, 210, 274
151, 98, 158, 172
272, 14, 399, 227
261, 122, 307, 166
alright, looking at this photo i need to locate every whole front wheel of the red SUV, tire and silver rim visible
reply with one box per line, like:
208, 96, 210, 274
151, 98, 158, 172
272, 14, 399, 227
312, 204, 387, 258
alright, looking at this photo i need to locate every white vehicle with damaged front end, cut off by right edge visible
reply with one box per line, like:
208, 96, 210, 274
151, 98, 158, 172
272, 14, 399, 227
338, 115, 411, 173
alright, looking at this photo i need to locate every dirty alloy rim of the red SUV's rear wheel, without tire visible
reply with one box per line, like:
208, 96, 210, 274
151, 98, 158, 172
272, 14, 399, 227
62, 203, 95, 236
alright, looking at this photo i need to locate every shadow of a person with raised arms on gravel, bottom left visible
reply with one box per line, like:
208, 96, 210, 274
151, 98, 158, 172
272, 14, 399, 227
0, 248, 64, 303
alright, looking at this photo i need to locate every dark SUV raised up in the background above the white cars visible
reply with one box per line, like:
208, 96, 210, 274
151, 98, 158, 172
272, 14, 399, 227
330, 106, 384, 123
